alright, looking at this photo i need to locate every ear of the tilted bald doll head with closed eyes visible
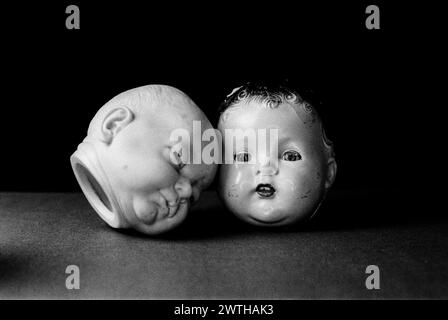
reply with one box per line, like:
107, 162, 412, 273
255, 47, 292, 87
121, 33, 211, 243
101, 107, 134, 144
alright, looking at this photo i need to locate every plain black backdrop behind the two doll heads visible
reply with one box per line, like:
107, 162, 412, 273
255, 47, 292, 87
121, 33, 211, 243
0, 1, 429, 198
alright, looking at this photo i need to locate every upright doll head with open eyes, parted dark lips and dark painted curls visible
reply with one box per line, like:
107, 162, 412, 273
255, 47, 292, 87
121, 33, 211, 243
218, 83, 337, 226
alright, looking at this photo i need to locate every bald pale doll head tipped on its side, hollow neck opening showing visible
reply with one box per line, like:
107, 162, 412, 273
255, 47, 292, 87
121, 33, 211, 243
71, 85, 216, 234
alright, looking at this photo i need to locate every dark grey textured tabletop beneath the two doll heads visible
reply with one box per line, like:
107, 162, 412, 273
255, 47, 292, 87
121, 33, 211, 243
0, 190, 448, 299
